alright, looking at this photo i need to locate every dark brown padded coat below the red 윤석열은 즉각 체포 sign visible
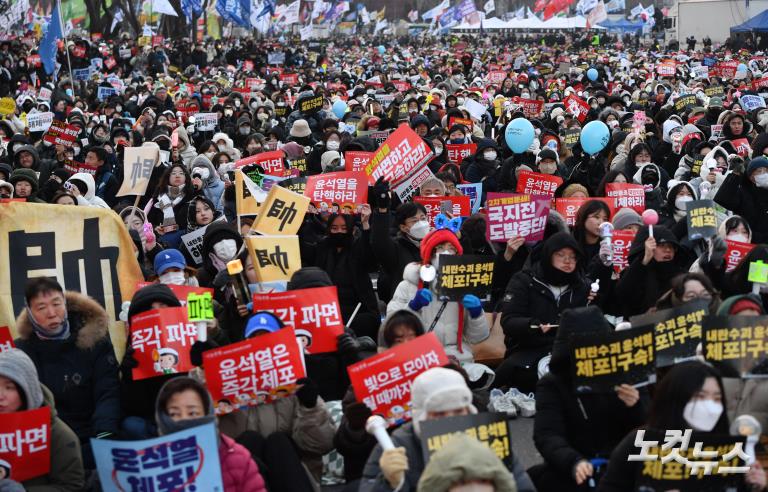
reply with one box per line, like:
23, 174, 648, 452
219, 396, 336, 480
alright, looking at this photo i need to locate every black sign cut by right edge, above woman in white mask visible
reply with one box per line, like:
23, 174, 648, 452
703, 316, 768, 378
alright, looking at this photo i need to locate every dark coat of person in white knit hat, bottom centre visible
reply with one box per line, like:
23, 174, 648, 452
358, 423, 536, 492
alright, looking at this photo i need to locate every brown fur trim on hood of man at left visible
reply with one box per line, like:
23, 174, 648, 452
16, 290, 109, 350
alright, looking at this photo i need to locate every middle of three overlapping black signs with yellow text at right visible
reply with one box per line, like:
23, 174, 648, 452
629, 299, 709, 367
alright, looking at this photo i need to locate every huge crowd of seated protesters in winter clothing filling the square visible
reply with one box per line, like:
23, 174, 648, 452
0, 27, 768, 492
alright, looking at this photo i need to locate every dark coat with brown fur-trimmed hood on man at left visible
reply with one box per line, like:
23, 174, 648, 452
16, 291, 120, 442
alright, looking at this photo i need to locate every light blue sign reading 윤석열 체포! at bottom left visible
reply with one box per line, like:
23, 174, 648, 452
91, 422, 224, 492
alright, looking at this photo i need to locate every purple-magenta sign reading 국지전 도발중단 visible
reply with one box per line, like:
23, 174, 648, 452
485, 193, 550, 242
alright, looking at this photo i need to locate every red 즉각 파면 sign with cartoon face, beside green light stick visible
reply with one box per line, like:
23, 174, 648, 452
131, 306, 197, 381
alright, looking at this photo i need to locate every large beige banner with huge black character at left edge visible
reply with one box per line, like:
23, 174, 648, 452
0, 202, 144, 359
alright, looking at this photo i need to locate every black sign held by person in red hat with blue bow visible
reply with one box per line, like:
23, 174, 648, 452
434, 255, 493, 301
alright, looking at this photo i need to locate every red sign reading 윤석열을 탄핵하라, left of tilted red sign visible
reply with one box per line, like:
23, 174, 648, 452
304, 171, 368, 211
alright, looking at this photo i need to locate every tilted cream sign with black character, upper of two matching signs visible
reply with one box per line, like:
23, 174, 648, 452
251, 186, 309, 236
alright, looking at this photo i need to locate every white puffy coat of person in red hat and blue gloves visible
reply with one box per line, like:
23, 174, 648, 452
387, 263, 491, 362
